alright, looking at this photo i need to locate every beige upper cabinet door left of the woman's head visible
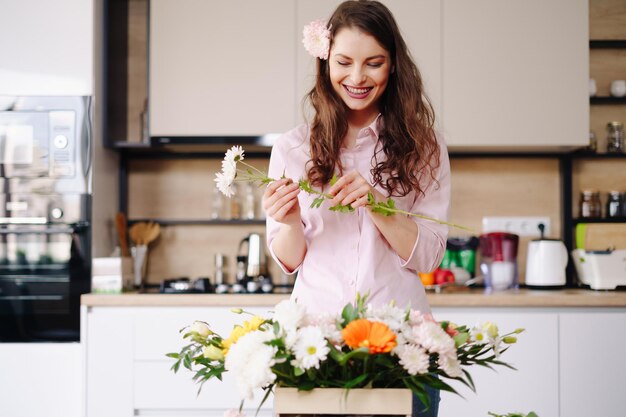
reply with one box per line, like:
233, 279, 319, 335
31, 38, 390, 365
149, 0, 296, 136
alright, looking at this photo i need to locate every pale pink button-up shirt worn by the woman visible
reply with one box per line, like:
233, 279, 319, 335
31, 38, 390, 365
267, 117, 450, 313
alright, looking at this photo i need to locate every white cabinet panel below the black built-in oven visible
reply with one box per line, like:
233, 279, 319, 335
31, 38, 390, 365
0, 343, 84, 417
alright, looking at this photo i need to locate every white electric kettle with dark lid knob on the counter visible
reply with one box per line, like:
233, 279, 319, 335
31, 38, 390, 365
526, 224, 568, 288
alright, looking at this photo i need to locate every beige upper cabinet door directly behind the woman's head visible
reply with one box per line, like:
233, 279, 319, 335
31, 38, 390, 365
297, 0, 441, 128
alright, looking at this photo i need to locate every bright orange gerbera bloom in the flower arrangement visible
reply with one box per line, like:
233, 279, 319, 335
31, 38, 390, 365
341, 319, 397, 354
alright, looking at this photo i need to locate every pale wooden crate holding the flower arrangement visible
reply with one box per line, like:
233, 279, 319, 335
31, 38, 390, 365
274, 387, 413, 417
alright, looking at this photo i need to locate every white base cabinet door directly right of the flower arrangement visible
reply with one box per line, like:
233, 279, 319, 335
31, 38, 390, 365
433, 308, 556, 417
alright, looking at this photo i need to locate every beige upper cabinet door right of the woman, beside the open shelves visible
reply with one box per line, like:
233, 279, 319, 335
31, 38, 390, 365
443, 0, 589, 148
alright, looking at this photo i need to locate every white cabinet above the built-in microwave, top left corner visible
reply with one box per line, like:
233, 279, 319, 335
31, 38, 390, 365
0, 0, 94, 96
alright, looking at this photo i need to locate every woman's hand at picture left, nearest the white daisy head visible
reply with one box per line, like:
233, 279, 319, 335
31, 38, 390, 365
263, 178, 302, 225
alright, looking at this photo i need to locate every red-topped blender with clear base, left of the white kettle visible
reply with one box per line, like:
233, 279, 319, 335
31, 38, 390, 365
480, 232, 519, 292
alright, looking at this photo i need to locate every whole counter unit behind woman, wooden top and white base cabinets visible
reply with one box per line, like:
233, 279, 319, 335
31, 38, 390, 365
81, 289, 626, 417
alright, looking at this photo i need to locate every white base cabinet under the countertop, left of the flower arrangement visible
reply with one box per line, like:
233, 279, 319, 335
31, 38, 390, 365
83, 307, 273, 417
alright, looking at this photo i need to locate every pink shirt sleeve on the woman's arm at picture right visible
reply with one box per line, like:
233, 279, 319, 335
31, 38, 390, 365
398, 137, 450, 272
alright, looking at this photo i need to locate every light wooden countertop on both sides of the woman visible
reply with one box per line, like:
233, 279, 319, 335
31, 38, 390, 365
81, 289, 626, 308
